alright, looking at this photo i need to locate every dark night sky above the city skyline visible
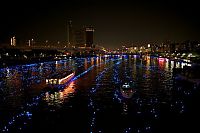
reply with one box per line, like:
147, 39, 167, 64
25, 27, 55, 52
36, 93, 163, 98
0, 0, 200, 48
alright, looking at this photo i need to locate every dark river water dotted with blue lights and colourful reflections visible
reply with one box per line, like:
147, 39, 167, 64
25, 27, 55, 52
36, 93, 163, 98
0, 55, 198, 133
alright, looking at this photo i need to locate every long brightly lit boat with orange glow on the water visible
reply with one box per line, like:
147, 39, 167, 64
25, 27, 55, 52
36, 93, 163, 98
46, 72, 75, 85
